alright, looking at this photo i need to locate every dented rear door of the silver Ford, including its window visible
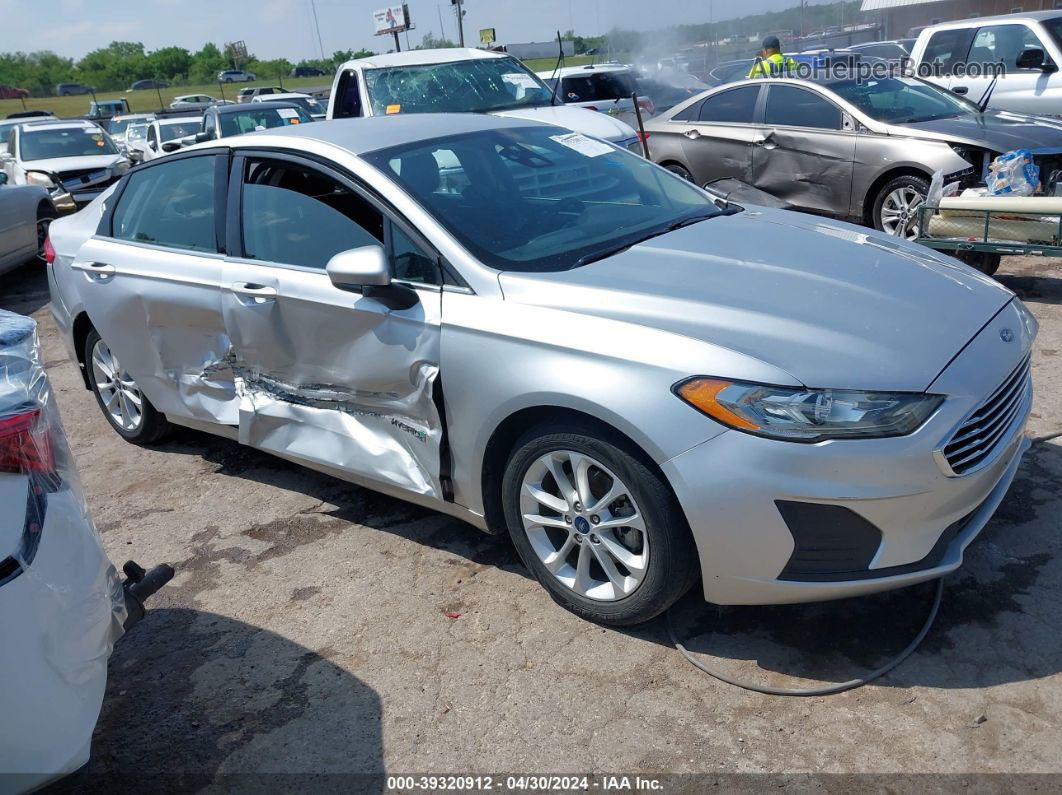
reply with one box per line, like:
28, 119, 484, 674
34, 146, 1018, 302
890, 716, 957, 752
70, 153, 238, 425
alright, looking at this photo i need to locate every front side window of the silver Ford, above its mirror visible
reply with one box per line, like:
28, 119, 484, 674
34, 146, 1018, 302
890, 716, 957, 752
242, 159, 383, 270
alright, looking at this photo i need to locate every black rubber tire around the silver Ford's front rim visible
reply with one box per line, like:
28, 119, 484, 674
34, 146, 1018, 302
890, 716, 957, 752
501, 421, 700, 626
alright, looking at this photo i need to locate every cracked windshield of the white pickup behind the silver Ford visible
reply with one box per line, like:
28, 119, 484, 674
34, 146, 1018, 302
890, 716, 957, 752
365, 58, 550, 116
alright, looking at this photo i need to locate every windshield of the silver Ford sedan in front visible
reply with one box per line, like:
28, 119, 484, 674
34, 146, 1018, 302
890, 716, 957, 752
364, 127, 720, 272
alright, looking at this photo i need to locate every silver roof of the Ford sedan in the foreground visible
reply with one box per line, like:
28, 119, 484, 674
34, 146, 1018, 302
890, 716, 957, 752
217, 114, 552, 156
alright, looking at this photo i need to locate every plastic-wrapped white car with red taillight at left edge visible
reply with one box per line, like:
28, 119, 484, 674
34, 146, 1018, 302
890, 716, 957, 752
0, 311, 173, 792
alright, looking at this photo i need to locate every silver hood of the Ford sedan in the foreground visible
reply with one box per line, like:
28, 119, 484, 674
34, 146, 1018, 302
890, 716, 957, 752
500, 208, 1013, 392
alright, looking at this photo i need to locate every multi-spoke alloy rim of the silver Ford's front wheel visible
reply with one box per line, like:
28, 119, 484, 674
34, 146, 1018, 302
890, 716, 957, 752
520, 450, 649, 602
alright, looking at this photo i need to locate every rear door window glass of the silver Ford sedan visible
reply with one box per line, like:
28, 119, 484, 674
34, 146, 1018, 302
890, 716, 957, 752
113, 155, 218, 252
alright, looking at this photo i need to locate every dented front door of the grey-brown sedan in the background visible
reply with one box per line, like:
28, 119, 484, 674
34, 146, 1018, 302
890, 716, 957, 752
752, 83, 856, 215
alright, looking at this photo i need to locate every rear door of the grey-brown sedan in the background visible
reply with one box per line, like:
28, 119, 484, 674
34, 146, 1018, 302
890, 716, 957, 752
673, 84, 763, 185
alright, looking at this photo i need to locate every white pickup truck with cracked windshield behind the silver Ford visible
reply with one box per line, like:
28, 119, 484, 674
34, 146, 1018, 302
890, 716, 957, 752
328, 48, 641, 154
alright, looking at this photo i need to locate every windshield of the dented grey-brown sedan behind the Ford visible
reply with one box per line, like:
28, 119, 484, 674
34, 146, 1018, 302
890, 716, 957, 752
828, 77, 977, 124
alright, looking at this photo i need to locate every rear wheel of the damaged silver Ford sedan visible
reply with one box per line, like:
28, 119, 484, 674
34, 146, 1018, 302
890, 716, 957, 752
85, 329, 172, 445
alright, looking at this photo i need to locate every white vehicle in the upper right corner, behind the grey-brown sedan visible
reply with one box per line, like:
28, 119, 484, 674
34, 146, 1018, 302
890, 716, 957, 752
911, 11, 1062, 116
